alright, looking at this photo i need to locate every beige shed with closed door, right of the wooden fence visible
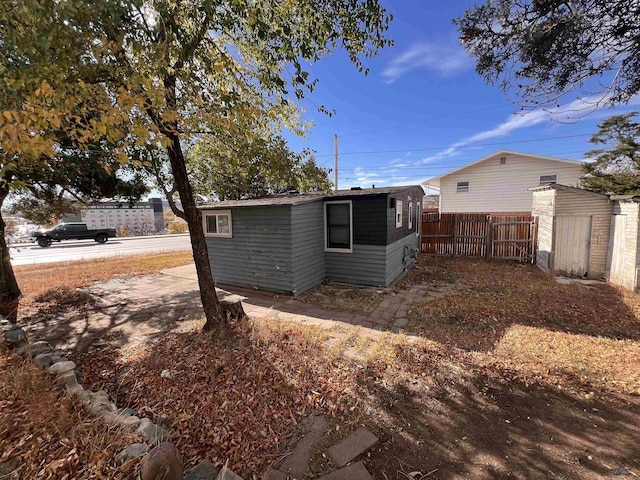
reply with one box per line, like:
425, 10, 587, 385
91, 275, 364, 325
530, 184, 614, 279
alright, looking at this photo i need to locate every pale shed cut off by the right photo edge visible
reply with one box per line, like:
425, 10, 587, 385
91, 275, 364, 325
609, 196, 640, 290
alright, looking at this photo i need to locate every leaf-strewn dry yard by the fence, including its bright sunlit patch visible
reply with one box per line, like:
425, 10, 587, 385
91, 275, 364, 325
411, 257, 640, 394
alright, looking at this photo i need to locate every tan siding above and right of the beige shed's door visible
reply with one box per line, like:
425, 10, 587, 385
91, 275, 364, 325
555, 190, 613, 278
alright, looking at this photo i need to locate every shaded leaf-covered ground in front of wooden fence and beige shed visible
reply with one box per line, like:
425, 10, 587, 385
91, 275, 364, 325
409, 257, 640, 351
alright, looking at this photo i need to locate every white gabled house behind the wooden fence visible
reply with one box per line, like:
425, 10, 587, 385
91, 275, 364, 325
424, 150, 582, 214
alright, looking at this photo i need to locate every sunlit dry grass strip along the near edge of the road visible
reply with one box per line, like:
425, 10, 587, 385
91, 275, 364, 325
14, 252, 193, 303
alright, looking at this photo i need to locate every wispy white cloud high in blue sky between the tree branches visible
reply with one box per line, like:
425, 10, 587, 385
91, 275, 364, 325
382, 43, 472, 83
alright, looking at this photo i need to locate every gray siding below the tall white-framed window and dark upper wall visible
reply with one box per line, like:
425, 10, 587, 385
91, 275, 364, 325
324, 244, 387, 287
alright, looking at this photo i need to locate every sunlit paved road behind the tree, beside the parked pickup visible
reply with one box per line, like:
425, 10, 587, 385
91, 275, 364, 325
11, 235, 191, 265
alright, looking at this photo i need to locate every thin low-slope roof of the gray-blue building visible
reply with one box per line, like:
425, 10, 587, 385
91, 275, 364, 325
198, 185, 424, 210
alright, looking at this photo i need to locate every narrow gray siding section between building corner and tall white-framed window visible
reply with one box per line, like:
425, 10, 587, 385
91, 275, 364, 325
291, 200, 325, 295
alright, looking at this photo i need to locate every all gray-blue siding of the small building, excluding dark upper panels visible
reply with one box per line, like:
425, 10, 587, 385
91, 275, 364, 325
206, 201, 418, 295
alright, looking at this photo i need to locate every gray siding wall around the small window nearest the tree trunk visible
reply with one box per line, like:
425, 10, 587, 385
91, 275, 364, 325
204, 205, 294, 292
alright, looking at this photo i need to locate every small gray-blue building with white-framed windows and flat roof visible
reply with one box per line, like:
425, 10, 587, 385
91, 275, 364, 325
200, 185, 424, 295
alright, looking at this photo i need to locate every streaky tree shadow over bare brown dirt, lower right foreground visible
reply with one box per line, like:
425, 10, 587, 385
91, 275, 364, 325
361, 360, 640, 480
